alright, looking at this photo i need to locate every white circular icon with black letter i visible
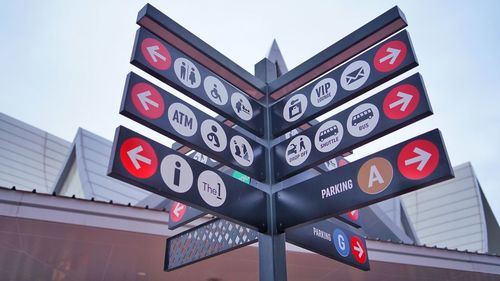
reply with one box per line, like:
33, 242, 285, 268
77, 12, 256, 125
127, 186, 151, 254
160, 154, 193, 193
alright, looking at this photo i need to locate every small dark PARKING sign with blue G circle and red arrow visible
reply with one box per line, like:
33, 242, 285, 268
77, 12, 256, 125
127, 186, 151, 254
286, 219, 370, 270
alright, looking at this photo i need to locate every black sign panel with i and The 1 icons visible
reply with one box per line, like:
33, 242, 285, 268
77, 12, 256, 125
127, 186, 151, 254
108, 127, 267, 230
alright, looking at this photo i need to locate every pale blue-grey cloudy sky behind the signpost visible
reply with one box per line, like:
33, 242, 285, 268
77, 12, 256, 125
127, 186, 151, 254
0, 0, 500, 221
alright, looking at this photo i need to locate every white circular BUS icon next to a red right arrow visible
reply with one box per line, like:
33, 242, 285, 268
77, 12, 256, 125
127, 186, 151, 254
347, 103, 380, 137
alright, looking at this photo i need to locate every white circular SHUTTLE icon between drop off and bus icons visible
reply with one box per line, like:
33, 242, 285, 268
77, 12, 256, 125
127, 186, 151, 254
314, 120, 344, 152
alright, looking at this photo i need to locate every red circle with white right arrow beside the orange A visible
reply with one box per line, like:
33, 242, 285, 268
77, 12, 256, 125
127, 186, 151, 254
398, 140, 439, 180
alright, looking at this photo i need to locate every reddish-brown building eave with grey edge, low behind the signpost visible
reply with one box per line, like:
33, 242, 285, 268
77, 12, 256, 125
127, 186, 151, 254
0, 185, 500, 281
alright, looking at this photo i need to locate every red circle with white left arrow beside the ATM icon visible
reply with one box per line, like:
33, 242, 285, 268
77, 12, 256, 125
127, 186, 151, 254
132, 83, 165, 119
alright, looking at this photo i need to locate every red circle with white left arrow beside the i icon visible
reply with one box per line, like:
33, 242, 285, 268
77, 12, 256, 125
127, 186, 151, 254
120, 138, 158, 179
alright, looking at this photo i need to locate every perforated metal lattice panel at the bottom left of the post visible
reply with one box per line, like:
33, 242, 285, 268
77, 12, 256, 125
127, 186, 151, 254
165, 219, 258, 271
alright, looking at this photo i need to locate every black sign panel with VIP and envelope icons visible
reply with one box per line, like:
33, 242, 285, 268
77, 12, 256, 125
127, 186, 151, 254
271, 31, 418, 136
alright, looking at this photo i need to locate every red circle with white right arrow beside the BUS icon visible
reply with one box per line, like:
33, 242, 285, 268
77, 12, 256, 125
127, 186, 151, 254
384, 84, 420, 119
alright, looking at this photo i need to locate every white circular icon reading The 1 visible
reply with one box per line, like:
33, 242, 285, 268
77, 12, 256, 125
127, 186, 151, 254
198, 171, 226, 207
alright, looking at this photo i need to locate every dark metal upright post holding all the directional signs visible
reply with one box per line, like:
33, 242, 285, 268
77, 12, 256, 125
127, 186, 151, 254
255, 59, 287, 281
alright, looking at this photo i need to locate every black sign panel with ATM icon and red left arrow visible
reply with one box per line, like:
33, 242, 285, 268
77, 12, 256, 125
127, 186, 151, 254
120, 73, 265, 180
